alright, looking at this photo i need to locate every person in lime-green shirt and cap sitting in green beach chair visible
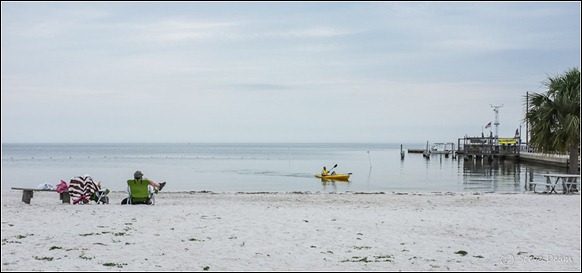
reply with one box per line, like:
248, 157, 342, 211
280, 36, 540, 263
121, 171, 166, 205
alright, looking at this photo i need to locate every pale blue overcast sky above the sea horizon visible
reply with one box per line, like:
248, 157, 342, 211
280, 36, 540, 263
1, 1, 581, 143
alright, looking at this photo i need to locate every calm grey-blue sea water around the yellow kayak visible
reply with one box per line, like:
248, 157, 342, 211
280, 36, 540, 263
2, 143, 565, 192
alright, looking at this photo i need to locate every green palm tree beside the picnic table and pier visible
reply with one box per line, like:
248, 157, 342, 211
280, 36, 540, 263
525, 68, 580, 174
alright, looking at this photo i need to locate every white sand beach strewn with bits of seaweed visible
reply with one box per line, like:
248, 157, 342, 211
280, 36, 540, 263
2, 191, 581, 271
